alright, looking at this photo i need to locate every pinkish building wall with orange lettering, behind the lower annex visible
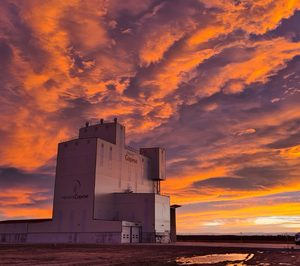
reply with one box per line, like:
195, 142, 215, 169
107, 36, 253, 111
94, 139, 155, 220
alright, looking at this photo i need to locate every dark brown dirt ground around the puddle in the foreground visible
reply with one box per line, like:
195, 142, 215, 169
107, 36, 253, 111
0, 244, 300, 266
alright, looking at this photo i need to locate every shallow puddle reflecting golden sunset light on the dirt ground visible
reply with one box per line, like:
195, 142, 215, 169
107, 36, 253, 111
176, 253, 254, 266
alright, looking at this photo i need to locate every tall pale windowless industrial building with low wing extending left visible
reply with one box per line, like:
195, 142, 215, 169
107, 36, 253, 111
0, 118, 178, 243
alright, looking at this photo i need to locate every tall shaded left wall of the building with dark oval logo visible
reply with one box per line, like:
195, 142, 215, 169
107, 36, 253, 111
53, 139, 97, 232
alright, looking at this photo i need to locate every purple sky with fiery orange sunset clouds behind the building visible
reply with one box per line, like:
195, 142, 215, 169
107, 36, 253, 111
0, 0, 300, 234
